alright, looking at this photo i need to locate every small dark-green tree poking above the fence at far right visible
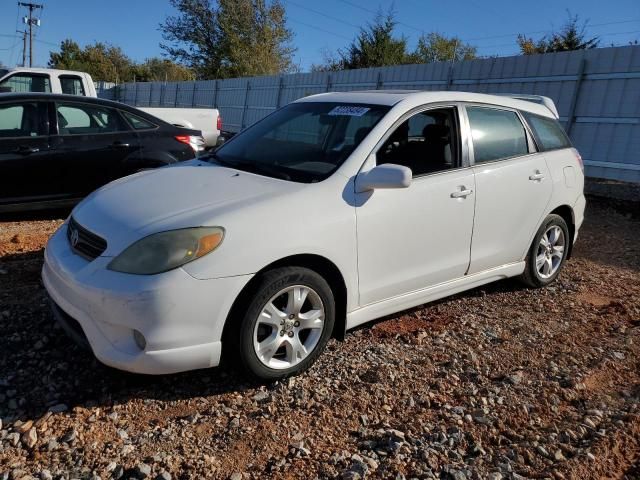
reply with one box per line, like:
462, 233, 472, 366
517, 12, 600, 55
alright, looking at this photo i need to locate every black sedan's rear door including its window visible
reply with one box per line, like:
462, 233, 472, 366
51, 101, 140, 197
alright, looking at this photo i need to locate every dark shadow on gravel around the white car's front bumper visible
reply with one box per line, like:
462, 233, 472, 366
0, 250, 256, 422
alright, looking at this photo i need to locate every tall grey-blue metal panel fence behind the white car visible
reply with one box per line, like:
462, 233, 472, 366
99, 46, 640, 182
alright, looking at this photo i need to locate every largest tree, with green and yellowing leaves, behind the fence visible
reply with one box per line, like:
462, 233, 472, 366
160, 0, 295, 79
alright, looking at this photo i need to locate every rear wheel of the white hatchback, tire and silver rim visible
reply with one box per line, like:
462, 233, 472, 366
520, 214, 571, 288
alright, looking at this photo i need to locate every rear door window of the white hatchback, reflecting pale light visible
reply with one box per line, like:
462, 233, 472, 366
467, 107, 529, 163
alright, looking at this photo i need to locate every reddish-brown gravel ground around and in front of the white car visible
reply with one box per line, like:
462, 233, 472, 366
0, 200, 640, 480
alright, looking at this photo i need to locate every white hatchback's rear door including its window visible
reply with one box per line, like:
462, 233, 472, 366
466, 105, 552, 274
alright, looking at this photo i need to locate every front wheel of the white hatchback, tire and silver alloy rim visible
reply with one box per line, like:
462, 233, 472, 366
234, 267, 335, 381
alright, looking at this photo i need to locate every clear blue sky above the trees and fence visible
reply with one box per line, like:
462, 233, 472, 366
0, 0, 640, 71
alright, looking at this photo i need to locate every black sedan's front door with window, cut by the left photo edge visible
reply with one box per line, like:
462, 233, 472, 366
0, 101, 62, 205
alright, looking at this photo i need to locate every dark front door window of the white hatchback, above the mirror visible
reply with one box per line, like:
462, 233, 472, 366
376, 108, 459, 177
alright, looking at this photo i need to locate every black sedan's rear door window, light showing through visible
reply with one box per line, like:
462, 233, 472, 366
56, 103, 129, 135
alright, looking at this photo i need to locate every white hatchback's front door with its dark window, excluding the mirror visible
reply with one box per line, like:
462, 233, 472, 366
356, 107, 475, 306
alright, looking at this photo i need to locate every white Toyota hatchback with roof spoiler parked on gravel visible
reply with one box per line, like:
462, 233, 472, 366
43, 91, 585, 380
